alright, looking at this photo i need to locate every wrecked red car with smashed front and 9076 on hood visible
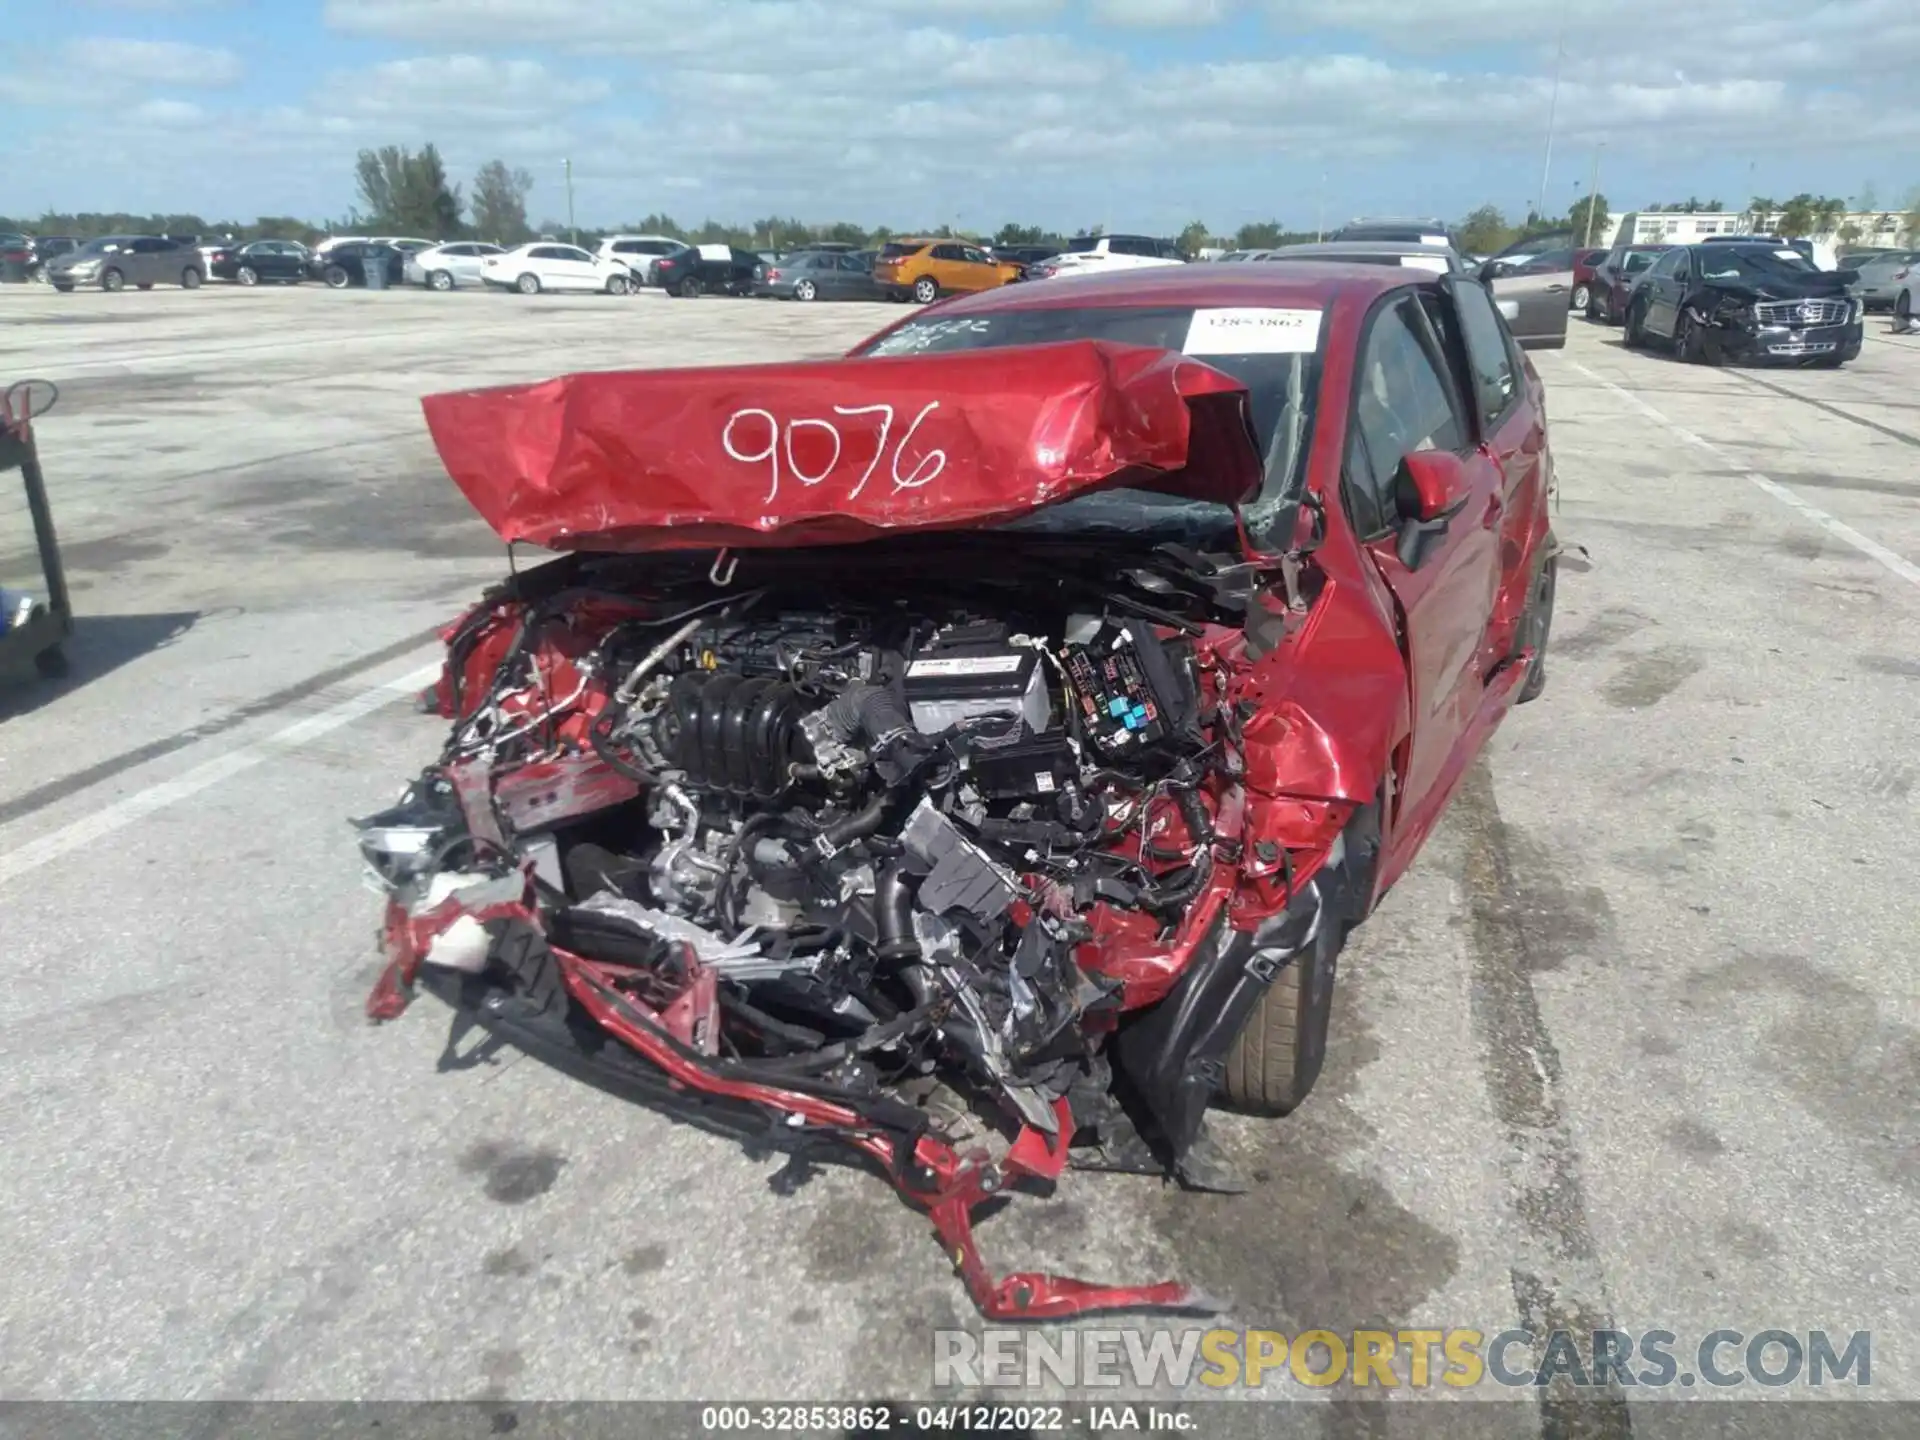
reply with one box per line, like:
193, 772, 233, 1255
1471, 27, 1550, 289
357, 263, 1555, 1319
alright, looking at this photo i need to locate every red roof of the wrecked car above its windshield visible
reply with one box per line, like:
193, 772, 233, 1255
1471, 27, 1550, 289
898, 261, 1434, 315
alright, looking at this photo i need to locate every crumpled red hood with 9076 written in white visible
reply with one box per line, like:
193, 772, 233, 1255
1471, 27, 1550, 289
420, 340, 1260, 551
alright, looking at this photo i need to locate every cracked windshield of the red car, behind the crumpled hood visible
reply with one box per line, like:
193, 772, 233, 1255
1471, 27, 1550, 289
856, 305, 1321, 545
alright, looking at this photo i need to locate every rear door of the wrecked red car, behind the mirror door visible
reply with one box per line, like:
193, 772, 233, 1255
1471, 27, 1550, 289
1423, 276, 1551, 676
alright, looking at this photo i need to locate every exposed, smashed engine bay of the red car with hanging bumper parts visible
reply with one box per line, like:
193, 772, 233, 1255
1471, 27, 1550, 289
357, 536, 1367, 1319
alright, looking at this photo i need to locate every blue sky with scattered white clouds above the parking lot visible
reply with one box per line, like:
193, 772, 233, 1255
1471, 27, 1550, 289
0, 0, 1920, 230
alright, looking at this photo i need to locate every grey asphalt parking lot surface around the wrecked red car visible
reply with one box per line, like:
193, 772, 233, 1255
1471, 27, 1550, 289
0, 286, 1920, 1434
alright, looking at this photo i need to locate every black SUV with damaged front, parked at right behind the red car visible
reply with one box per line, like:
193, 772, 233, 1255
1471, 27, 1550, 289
1626, 240, 1866, 367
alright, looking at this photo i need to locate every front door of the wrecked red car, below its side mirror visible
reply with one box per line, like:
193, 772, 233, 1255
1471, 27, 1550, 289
1342, 288, 1505, 843
